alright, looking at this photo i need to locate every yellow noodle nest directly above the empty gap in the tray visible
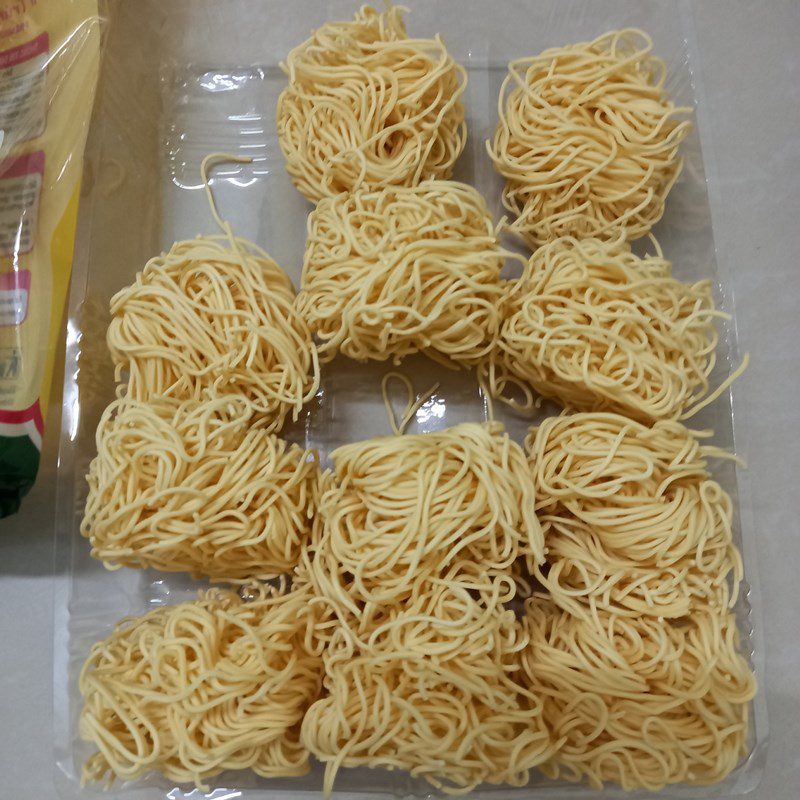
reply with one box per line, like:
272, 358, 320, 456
297, 181, 510, 365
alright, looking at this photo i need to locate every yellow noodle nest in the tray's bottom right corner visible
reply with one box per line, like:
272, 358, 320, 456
521, 597, 756, 791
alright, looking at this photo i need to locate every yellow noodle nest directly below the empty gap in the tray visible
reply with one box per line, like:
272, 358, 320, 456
304, 423, 544, 614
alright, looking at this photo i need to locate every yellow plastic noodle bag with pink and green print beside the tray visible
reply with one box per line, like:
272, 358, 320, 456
0, 0, 100, 516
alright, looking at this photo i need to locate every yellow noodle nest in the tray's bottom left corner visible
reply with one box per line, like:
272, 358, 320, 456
79, 587, 322, 791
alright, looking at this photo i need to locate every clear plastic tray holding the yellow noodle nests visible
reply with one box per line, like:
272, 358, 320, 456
54, 0, 767, 800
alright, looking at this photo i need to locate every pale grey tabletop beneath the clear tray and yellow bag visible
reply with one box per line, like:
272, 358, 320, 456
0, 0, 800, 800
